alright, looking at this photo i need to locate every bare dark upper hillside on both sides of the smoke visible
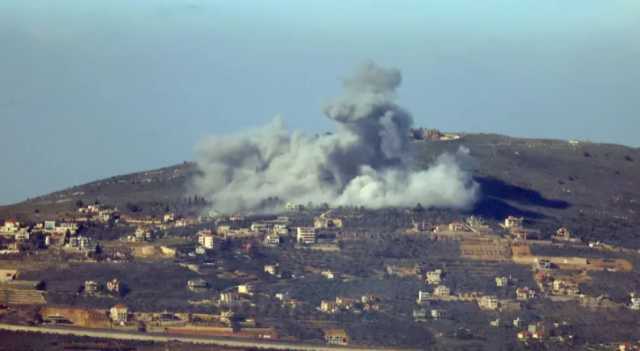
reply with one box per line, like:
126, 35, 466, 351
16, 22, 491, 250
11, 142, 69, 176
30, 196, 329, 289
0, 134, 640, 247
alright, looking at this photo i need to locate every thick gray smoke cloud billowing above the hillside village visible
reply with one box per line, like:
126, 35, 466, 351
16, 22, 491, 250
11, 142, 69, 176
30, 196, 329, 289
194, 63, 477, 213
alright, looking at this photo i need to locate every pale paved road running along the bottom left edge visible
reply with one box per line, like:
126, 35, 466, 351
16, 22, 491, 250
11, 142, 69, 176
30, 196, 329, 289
0, 323, 422, 351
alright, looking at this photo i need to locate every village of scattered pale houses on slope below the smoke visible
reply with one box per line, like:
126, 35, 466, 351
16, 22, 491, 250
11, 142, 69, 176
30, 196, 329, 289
0, 203, 640, 350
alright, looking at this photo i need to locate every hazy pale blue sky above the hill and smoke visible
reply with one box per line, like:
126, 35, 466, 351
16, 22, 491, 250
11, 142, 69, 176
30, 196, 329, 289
0, 0, 640, 204
